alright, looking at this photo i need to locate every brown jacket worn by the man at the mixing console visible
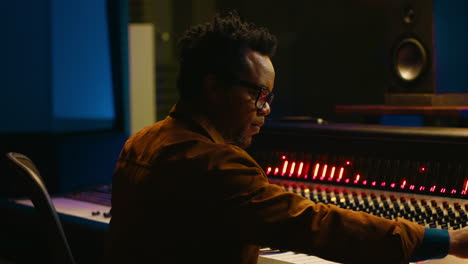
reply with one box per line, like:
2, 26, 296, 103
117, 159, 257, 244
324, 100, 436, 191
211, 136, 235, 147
106, 104, 424, 264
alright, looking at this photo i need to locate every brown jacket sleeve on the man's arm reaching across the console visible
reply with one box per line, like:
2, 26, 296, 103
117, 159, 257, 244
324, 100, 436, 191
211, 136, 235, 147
210, 145, 424, 264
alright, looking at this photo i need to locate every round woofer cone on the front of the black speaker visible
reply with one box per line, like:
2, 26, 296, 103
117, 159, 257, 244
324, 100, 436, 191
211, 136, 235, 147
393, 38, 427, 83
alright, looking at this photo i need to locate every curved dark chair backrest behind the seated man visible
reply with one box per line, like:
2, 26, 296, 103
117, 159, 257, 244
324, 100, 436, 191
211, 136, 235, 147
6, 152, 75, 264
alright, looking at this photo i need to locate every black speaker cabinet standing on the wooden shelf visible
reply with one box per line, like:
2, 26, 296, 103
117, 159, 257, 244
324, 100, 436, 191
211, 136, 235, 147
387, 0, 435, 93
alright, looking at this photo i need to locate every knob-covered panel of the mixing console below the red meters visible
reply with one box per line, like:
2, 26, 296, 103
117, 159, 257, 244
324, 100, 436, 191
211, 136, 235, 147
270, 179, 468, 229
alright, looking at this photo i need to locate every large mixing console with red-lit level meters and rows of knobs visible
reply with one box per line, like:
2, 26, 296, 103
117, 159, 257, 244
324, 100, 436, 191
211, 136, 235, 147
245, 123, 468, 264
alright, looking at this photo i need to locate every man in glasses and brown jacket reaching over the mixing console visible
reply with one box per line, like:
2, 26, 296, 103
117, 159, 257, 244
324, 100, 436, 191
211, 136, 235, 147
107, 11, 468, 264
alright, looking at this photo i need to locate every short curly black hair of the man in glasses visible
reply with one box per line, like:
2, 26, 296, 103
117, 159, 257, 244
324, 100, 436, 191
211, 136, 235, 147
177, 11, 277, 100
